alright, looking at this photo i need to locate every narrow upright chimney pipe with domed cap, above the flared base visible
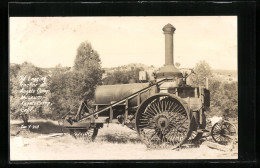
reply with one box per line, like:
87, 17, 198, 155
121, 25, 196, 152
162, 23, 176, 65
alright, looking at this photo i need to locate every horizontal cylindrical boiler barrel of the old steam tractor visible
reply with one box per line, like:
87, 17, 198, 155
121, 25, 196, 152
95, 83, 151, 107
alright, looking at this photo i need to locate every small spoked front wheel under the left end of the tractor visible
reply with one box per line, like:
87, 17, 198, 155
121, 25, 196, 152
70, 128, 98, 142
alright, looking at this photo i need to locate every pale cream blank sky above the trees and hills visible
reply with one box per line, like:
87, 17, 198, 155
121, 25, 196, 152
9, 16, 237, 70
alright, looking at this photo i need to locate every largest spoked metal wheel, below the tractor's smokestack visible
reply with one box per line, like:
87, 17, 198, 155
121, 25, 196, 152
136, 94, 191, 148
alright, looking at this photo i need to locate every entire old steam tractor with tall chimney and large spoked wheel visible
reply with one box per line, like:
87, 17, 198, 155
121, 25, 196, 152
63, 24, 213, 147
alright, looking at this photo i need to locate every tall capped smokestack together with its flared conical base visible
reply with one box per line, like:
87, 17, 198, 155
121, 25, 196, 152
156, 23, 182, 79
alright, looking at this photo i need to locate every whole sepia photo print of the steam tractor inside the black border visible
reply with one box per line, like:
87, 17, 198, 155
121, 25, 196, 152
9, 16, 239, 161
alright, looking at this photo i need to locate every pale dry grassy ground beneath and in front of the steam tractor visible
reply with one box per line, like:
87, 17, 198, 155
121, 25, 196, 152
10, 120, 237, 160
